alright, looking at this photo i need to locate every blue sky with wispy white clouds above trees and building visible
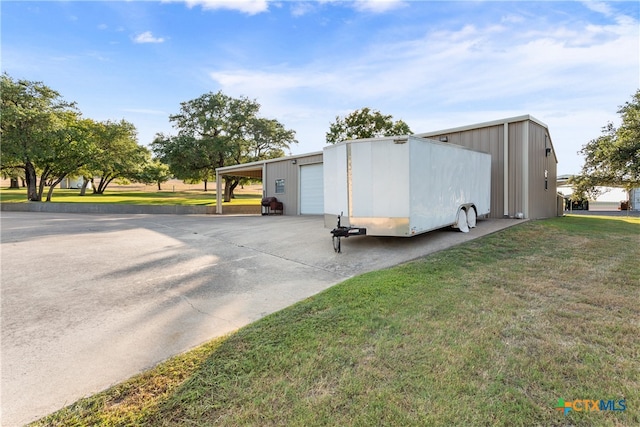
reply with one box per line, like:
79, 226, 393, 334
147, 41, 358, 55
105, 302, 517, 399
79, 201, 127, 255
0, 0, 640, 174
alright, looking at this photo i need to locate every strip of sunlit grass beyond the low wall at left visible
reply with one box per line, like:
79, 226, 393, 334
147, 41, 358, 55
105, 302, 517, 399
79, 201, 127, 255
0, 188, 262, 206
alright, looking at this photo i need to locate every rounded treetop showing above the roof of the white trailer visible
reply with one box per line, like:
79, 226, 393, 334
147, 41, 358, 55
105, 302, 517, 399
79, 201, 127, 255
326, 107, 413, 144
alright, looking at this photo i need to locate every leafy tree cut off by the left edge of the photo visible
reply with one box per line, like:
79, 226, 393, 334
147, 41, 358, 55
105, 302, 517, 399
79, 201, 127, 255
0, 73, 79, 201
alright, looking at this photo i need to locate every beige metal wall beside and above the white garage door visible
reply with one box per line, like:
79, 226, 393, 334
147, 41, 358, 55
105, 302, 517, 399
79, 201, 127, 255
262, 153, 322, 215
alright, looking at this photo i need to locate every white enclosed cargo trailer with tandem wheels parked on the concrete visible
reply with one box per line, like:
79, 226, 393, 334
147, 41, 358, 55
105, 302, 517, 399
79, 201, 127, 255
323, 136, 491, 250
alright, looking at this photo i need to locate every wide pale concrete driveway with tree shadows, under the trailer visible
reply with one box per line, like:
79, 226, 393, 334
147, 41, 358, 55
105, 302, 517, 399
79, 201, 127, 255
0, 212, 519, 426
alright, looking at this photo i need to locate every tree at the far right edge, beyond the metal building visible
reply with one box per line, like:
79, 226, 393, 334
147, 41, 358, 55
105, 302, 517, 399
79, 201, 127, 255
571, 90, 640, 196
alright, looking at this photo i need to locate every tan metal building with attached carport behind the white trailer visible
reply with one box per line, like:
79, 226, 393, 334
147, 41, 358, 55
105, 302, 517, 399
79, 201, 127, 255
216, 115, 561, 218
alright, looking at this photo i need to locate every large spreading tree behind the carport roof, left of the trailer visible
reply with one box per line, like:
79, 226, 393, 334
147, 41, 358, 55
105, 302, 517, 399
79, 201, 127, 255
152, 92, 296, 202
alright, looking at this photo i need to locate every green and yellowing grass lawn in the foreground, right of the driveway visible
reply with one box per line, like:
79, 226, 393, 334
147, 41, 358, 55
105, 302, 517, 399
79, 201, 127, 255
28, 216, 640, 426
